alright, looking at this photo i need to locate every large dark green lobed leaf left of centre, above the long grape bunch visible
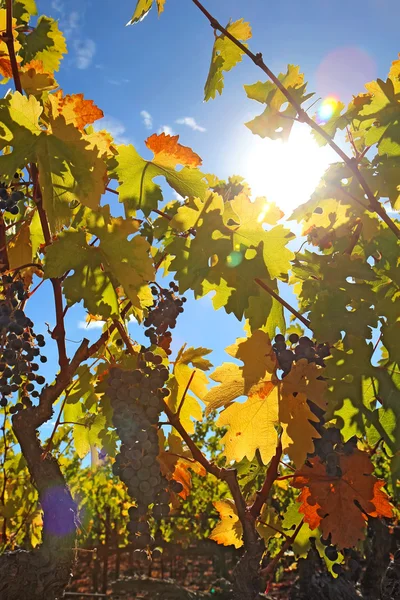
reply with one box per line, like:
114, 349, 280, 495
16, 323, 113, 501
45, 206, 154, 319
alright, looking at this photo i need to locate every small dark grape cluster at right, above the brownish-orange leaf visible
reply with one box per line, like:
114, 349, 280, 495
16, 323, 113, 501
272, 333, 330, 377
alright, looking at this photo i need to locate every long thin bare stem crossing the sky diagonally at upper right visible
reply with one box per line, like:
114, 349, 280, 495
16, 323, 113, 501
192, 0, 400, 239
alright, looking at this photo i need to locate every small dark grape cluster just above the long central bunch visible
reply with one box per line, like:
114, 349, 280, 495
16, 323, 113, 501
144, 281, 186, 356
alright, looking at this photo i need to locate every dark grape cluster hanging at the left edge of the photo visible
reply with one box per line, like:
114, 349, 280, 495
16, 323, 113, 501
0, 275, 47, 414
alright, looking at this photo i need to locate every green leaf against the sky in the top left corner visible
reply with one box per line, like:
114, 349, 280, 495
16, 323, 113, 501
24, 16, 67, 73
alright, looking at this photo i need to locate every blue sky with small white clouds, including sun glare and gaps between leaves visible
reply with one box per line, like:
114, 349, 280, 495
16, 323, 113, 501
17, 0, 400, 432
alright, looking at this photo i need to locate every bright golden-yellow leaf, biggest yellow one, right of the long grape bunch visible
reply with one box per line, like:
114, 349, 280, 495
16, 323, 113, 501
217, 381, 278, 464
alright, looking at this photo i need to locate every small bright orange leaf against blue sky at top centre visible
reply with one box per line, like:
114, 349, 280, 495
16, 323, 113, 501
146, 133, 202, 168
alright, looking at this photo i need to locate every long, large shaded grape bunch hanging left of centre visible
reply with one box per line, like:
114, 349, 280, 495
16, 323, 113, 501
108, 351, 182, 550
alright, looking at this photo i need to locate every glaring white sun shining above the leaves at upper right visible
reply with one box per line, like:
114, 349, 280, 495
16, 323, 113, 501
238, 123, 337, 217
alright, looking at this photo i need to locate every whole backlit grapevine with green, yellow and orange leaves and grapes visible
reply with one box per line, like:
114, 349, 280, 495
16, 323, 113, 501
0, 0, 400, 600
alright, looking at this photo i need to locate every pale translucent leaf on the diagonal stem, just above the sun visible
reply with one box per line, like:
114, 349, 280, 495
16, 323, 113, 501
244, 65, 314, 141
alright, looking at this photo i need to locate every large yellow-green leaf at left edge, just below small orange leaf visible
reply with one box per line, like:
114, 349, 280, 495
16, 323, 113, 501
0, 92, 106, 230
